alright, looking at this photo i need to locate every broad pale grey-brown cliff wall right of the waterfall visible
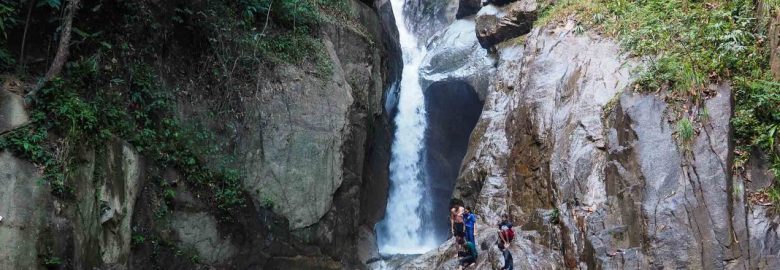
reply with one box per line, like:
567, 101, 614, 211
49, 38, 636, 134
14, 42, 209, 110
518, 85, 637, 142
399, 1, 778, 269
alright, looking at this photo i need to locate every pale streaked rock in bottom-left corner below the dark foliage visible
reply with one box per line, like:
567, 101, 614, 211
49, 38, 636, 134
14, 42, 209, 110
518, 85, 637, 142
0, 137, 144, 269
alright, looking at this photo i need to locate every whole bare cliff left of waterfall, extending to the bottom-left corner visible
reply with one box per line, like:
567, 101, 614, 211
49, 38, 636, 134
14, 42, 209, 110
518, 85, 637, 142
0, 1, 400, 269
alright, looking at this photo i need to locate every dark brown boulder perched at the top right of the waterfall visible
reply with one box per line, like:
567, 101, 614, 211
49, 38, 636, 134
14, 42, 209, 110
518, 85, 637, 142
477, 0, 539, 49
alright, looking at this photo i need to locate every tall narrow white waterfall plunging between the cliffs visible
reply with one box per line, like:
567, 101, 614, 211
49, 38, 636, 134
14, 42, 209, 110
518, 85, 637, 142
378, 0, 437, 254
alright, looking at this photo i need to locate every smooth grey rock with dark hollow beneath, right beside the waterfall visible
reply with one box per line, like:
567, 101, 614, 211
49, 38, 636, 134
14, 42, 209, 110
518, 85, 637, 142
420, 9, 495, 243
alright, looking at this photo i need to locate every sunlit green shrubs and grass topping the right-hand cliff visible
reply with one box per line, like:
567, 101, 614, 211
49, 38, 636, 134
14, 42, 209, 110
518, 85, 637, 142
545, 0, 764, 95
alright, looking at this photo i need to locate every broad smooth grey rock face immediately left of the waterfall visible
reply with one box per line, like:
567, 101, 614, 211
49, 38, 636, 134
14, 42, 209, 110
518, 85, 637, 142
171, 1, 401, 262
